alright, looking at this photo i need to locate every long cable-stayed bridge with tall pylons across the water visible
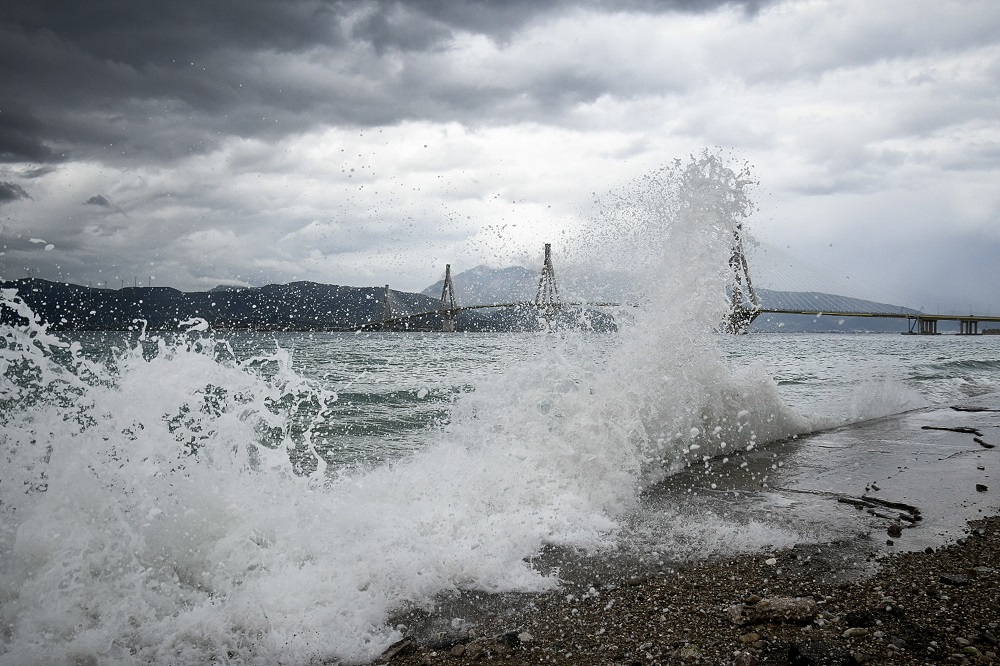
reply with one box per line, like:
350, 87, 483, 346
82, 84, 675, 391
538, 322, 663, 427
364, 237, 1000, 335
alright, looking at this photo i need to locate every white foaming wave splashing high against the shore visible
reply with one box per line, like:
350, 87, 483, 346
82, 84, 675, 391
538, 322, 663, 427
0, 155, 808, 664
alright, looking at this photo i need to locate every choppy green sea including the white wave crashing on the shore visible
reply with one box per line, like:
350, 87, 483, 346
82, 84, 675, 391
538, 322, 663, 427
0, 154, 1000, 664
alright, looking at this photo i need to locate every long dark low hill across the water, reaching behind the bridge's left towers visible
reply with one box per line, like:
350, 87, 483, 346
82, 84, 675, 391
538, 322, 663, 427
0, 278, 615, 332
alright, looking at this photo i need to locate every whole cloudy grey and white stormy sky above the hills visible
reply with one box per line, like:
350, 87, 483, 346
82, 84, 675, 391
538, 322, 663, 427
0, 0, 1000, 314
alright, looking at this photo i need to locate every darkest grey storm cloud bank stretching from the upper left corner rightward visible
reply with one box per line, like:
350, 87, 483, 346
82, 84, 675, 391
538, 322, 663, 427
0, 0, 772, 169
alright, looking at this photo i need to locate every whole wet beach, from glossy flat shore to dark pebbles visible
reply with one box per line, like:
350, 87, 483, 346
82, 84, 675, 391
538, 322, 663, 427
377, 395, 1000, 666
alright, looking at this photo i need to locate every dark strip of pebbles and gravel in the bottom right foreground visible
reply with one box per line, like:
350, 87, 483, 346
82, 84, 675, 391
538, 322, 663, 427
374, 516, 1000, 666
